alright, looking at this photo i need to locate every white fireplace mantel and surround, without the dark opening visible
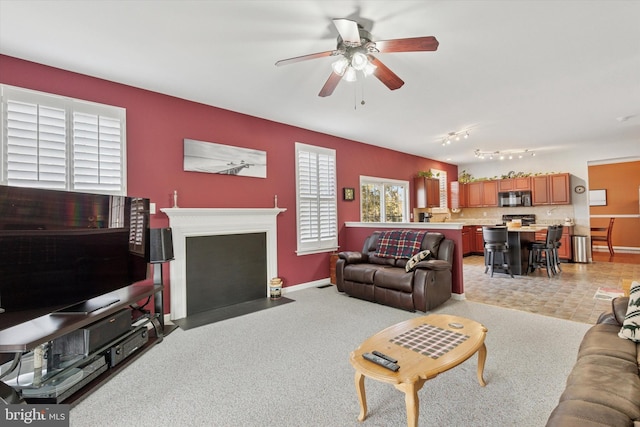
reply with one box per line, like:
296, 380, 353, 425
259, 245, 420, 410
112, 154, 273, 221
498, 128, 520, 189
160, 208, 286, 319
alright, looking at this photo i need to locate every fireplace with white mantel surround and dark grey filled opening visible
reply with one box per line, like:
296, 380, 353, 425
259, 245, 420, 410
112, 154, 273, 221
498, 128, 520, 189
161, 208, 286, 320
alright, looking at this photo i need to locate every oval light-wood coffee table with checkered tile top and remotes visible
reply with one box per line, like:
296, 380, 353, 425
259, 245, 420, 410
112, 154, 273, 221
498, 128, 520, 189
350, 314, 487, 427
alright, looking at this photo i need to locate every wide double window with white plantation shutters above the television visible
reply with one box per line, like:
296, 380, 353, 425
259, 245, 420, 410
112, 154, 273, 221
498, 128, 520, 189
0, 85, 126, 194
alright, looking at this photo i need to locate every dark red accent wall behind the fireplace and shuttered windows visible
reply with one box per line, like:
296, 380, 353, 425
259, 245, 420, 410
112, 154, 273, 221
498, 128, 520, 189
0, 55, 458, 308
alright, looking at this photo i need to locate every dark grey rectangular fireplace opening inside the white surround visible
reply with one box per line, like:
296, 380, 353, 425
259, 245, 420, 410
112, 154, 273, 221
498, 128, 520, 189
186, 233, 268, 315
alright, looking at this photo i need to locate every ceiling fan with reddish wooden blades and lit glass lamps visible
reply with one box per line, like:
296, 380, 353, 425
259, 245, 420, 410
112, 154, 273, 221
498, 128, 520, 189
276, 19, 439, 97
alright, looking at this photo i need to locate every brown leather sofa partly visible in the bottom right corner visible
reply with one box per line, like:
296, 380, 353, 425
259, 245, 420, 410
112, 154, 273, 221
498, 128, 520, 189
547, 297, 640, 427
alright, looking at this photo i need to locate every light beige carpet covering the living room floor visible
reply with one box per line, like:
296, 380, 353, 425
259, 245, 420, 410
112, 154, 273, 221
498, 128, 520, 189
70, 287, 589, 427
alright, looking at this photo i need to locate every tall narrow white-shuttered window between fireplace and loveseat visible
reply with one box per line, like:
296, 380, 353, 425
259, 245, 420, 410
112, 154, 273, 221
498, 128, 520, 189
295, 143, 338, 255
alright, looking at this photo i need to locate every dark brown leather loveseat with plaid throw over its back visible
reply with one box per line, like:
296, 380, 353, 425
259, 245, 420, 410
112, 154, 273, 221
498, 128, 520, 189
336, 231, 454, 312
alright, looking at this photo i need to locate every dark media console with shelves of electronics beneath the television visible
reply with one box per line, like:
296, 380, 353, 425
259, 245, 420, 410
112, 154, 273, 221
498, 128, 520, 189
0, 284, 164, 405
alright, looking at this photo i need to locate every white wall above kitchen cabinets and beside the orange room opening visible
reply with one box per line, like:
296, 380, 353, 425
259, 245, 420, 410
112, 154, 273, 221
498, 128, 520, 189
458, 140, 640, 235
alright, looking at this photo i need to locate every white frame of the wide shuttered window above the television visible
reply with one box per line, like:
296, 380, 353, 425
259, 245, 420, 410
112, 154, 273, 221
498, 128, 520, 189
0, 84, 127, 196
